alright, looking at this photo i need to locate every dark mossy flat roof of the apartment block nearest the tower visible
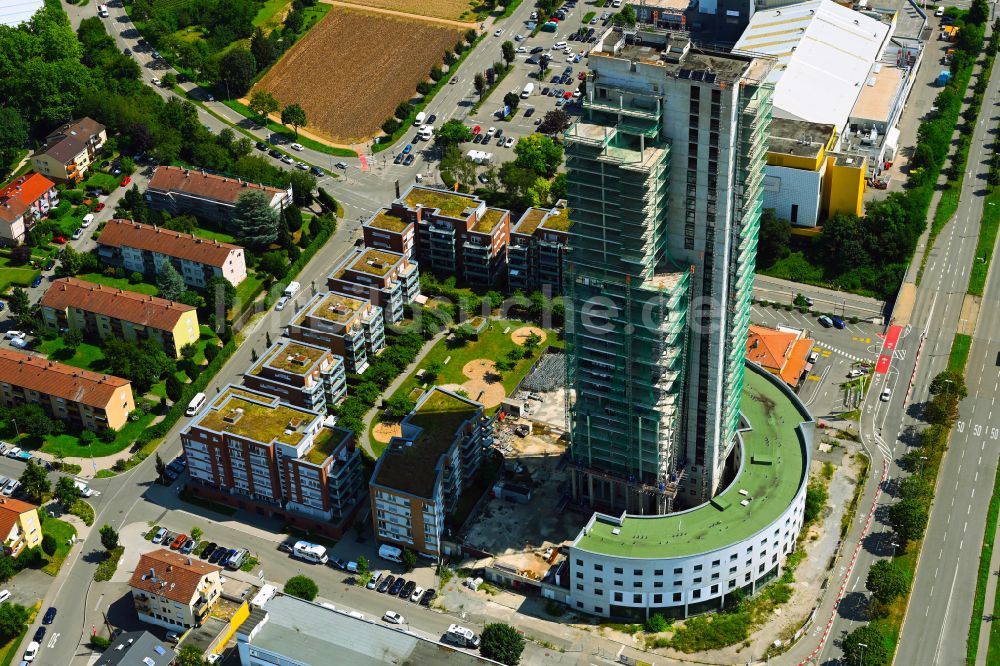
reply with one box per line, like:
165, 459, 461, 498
375, 386, 482, 497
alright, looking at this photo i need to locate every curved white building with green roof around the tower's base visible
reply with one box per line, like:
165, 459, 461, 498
569, 364, 815, 620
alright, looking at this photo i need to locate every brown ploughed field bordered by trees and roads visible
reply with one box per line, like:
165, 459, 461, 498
255, 5, 465, 143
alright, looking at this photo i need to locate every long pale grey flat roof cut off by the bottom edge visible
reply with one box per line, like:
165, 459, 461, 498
250, 593, 496, 666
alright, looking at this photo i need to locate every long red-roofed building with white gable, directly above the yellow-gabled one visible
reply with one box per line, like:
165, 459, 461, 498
97, 220, 247, 289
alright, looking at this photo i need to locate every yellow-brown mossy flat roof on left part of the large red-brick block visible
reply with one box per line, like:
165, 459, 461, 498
191, 385, 320, 446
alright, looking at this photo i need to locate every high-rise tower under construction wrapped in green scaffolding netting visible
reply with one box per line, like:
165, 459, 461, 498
565, 28, 773, 514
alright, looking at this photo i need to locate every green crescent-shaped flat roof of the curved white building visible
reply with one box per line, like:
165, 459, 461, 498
574, 365, 812, 559
